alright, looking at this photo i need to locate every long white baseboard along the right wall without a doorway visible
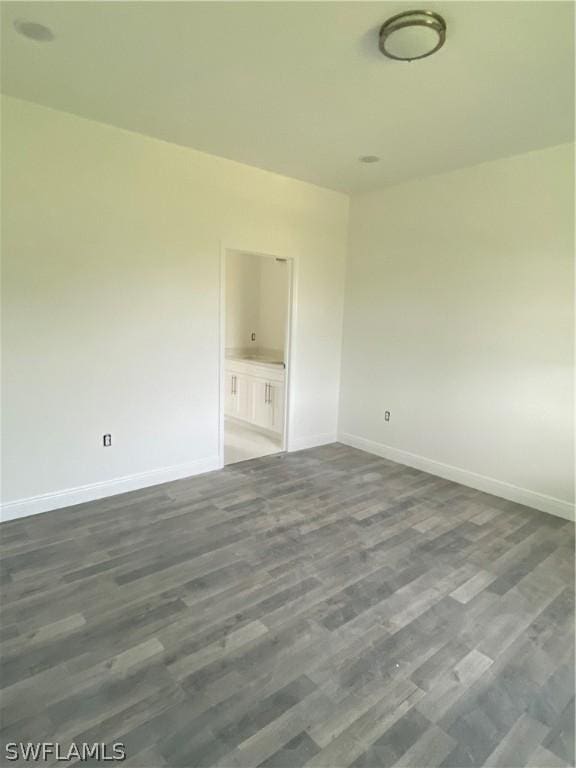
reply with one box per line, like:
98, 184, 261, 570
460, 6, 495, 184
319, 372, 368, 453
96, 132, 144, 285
338, 432, 574, 522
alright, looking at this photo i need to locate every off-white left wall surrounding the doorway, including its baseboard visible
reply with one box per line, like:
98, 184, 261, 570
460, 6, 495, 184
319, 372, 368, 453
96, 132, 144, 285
2, 97, 348, 519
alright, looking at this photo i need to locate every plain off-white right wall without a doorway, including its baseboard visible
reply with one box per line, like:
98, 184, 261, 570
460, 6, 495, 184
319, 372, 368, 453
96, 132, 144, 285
340, 145, 574, 517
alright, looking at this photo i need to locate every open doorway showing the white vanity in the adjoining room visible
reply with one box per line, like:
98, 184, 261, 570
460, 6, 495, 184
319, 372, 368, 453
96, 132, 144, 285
220, 250, 292, 465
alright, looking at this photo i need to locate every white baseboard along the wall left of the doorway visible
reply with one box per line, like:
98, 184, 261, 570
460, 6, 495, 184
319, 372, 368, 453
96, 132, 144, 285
0, 456, 222, 522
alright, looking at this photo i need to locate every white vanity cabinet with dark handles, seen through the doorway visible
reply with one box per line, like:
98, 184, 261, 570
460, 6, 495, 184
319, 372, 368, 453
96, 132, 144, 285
224, 360, 284, 434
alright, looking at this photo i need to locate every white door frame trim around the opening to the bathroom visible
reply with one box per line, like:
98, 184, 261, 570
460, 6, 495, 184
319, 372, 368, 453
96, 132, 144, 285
218, 245, 296, 468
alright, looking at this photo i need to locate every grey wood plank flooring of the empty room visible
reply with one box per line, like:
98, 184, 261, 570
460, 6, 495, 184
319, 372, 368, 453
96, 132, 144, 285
0, 444, 574, 768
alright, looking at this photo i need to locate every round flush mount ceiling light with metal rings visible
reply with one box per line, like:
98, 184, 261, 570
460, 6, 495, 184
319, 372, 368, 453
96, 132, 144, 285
379, 11, 446, 61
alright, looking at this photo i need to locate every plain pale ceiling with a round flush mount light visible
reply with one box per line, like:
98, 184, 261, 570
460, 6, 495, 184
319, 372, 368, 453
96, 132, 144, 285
2, 1, 574, 191
